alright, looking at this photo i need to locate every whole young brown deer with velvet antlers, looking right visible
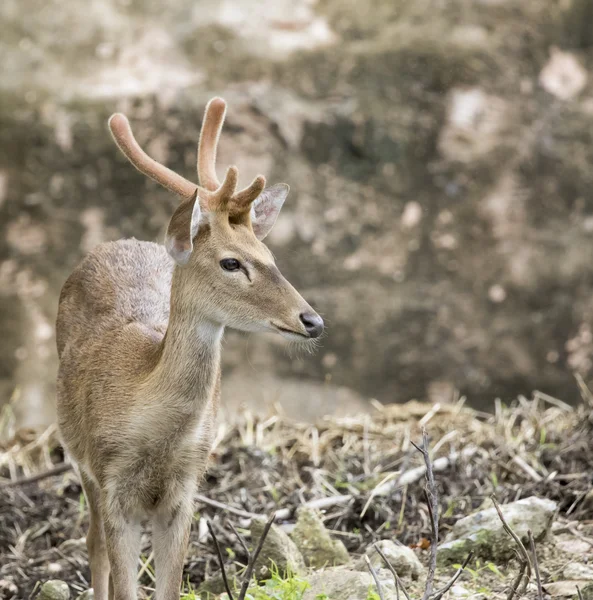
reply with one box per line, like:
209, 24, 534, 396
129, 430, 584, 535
56, 98, 323, 600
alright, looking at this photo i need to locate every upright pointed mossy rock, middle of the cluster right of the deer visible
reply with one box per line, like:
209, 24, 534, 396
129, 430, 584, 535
290, 506, 350, 569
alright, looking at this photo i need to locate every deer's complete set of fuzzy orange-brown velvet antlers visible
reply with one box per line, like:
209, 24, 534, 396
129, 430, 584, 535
109, 98, 266, 217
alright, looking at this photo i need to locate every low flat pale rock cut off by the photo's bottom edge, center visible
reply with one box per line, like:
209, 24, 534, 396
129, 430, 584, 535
303, 567, 397, 600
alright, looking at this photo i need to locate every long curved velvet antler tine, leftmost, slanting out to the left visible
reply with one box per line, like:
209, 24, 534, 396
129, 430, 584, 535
109, 113, 197, 198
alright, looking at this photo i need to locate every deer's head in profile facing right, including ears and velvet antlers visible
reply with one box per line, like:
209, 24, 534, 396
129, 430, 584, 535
109, 98, 323, 341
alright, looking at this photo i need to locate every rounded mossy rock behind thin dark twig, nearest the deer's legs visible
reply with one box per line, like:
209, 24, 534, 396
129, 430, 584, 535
251, 519, 305, 579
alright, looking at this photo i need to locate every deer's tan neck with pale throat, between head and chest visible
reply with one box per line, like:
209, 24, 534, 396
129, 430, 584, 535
154, 267, 224, 412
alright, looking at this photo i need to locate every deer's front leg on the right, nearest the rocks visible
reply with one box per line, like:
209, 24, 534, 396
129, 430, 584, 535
152, 495, 193, 600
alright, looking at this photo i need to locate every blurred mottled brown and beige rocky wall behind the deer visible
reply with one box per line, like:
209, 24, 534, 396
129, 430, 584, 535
0, 0, 593, 423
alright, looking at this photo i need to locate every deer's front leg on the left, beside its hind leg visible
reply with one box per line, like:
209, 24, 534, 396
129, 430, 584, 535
103, 503, 140, 600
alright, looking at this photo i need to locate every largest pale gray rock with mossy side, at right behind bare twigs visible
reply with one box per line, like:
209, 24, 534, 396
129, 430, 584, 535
438, 496, 556, 564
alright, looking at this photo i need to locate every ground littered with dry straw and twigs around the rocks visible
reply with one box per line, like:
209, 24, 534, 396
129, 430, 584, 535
0, 388, 593, 600
